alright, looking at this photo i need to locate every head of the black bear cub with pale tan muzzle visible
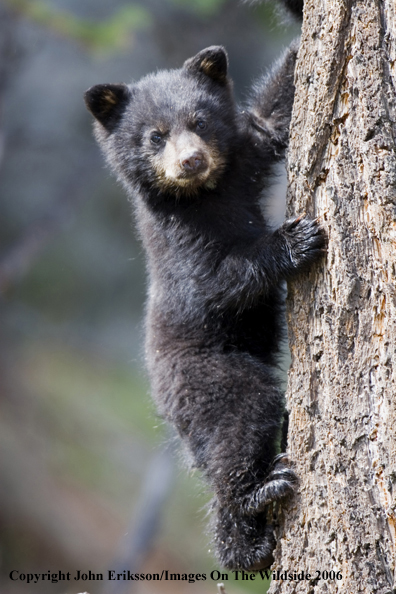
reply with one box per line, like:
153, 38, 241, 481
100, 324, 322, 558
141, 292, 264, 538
85, 46, 236, 197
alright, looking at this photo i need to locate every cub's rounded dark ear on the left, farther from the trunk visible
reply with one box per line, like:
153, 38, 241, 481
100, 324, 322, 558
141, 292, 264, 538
84, 83, 131, 131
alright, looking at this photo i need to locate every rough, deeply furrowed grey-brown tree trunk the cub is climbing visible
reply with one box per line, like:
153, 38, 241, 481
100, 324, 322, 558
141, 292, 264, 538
270, 0, 396, 594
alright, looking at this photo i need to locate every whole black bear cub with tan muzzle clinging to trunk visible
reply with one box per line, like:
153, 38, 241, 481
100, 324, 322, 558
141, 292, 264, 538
85, 46, 324, 570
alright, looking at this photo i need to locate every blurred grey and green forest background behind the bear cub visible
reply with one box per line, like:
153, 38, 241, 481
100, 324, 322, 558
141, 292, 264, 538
0, 0, 298, 594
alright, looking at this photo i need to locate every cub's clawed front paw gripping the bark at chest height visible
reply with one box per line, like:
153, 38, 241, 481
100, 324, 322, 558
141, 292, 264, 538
280, 216, 327, 274
